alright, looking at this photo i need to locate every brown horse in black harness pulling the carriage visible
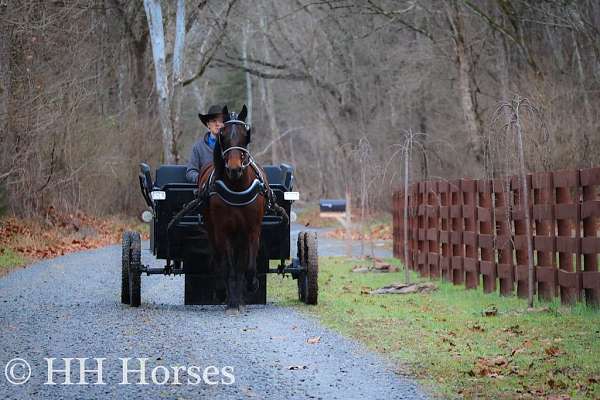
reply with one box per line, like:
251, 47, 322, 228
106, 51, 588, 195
198, 105, 270, 314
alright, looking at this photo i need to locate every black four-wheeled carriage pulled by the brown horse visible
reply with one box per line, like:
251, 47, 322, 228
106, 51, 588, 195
121, 163, 318, 307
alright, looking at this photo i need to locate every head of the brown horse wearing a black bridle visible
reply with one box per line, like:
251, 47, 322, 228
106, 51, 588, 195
215, 105, 252, 181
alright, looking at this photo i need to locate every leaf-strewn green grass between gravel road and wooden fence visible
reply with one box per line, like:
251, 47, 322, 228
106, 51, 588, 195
269, 257, 600, 399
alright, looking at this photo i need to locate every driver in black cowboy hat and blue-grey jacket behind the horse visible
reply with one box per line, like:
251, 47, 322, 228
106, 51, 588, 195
185, 105, 223, 183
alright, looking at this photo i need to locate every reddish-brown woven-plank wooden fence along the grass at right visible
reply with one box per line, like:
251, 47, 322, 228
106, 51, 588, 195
393, 168, 600, 306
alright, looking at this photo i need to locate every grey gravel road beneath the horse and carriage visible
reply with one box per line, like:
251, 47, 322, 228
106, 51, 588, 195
0, 238, 425, 399
